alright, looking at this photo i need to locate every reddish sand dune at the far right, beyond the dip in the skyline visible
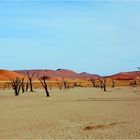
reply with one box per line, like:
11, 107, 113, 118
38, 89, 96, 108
107, 71, 140, 80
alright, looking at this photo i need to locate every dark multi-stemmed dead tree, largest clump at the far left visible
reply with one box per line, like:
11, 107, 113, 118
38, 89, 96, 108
10, 77, 22, 96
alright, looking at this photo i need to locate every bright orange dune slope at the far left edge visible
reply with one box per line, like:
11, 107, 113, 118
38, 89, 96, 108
0, 70, 23, 81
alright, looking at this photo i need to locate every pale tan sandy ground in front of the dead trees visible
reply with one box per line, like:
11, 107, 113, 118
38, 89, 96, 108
0, 88, 140, 139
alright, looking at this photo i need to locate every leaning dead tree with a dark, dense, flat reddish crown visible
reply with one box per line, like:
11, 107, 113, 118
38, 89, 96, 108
39, 75, 50, 97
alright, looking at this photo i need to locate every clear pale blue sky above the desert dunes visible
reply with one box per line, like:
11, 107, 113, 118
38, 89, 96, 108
0, 0, 140, 75
